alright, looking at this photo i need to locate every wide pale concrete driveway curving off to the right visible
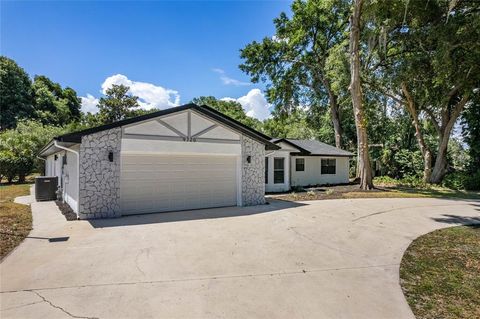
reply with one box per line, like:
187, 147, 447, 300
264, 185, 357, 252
0, 199, 480, 319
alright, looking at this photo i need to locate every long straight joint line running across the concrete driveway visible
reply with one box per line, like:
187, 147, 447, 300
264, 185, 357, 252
0, 263, 400, 296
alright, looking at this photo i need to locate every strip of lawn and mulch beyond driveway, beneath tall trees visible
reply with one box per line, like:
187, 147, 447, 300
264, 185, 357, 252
269, 184, 480, 201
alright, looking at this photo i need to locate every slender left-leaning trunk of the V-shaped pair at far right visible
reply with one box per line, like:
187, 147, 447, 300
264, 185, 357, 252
402, 83, 432, 183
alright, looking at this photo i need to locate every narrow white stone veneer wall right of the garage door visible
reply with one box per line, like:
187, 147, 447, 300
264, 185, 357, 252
242, 136, 265, 206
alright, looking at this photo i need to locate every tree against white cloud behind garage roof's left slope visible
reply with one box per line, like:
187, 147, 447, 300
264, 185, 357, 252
98, 84, 140, 124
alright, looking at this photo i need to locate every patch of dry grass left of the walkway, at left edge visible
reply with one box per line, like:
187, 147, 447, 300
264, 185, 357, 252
0, 184, 32, 260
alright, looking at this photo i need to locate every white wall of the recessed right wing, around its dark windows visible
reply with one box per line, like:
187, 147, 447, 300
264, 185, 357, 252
290, 156, 350, 186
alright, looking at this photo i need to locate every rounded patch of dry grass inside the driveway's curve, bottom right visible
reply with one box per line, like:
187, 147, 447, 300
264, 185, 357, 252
400, 225, 480, 318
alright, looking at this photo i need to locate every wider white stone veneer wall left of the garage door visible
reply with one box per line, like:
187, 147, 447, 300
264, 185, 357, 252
79, 128, 122, 219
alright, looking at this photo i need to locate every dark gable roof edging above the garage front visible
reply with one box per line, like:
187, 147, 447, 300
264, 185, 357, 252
48, 103, 279, 150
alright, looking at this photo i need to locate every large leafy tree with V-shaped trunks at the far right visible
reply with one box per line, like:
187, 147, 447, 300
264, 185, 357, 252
368, 0, 480, 183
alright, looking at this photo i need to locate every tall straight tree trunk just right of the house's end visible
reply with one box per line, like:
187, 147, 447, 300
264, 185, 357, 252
350, 0, 373, 190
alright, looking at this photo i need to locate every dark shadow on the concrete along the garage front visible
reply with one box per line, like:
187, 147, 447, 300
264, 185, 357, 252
88, 199, 308, 228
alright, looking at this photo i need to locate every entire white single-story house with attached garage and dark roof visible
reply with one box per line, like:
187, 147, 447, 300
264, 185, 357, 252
39, 104, 351, 219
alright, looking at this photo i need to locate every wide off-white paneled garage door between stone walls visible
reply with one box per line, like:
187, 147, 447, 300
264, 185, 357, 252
120, 154, 237, 215
